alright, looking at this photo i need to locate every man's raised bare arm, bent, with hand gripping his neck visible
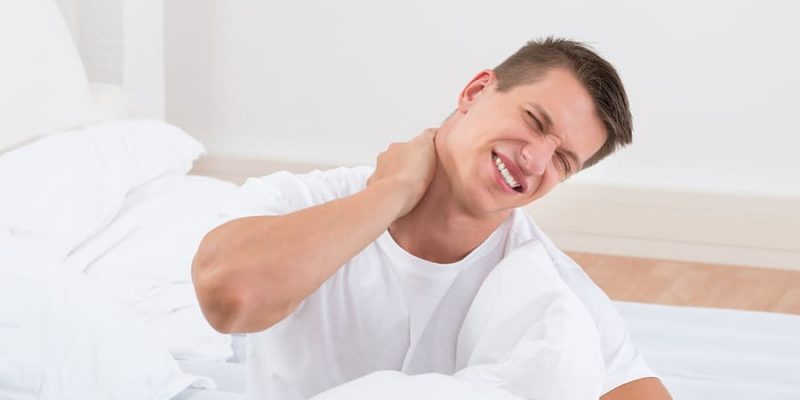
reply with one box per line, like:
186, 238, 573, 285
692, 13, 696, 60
192, 130, 436, 333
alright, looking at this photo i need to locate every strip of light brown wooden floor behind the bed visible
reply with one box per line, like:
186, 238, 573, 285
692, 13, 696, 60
569, 253, 800, 314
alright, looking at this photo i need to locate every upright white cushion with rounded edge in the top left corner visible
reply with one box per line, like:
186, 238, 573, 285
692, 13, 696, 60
0, 0, 89, 153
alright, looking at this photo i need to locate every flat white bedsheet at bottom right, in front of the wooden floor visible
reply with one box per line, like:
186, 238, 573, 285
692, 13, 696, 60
617, 302, 800, 400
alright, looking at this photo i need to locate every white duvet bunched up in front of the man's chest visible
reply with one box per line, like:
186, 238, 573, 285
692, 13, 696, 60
314, 242, 604, 400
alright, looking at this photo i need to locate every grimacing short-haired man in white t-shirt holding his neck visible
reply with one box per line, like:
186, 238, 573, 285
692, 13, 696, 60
193, 38, 670, 400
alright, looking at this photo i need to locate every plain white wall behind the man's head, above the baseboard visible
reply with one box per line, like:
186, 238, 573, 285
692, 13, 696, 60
165, 0, 800, 197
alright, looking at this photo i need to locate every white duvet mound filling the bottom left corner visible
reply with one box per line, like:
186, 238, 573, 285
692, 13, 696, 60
0, 248, 203, 399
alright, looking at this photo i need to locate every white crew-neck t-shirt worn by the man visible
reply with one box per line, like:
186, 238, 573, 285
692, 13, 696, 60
232, 167, 655, 400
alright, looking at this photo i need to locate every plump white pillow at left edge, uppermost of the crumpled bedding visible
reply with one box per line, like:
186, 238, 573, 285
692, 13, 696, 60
0, 120, 204, 257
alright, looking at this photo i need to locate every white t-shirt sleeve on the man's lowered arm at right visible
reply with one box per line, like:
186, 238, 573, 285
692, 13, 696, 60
561, 264, 658, 394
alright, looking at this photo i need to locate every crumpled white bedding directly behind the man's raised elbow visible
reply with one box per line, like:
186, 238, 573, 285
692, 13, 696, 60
67, 176, 236, 361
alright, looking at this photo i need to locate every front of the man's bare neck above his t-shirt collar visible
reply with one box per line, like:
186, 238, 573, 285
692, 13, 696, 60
389, 166, 509, 264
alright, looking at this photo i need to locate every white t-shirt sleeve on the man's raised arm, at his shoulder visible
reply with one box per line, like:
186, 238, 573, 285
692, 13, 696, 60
226, 166, 373, 219
